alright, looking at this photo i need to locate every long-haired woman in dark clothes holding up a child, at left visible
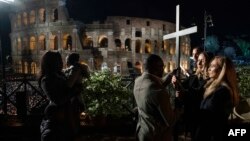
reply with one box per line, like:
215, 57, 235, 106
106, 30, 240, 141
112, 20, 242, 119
38, 51, 73, 141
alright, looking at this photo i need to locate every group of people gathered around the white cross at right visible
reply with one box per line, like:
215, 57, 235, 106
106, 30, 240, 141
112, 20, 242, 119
134, 48, 239, 141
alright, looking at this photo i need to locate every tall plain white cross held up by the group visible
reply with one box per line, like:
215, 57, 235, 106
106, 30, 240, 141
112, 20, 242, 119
163, 5, 197, 72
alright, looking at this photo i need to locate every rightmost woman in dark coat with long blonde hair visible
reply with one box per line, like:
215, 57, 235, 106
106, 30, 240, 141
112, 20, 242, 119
194, 56, 239, 141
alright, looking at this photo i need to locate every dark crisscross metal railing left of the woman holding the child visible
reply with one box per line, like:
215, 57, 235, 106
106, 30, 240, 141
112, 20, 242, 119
0, 74, 47, 115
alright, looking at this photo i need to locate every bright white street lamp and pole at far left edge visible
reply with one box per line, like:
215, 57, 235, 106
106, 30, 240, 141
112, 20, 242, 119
0, 0, 14, 114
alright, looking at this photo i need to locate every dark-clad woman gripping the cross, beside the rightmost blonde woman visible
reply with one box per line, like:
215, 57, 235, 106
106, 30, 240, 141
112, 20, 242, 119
172, 52, 213, 139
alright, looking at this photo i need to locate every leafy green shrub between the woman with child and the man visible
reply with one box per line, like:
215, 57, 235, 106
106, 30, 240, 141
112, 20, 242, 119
82, 70, 133, 117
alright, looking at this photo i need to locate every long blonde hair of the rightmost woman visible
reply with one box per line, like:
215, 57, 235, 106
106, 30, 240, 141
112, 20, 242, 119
204, 56, 239, 106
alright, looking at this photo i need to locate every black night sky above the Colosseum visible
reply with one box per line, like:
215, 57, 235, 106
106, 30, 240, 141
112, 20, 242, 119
67, 0, 250, 45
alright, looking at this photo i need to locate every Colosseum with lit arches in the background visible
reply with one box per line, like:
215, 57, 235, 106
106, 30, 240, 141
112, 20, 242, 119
10, 0, 191, 75
